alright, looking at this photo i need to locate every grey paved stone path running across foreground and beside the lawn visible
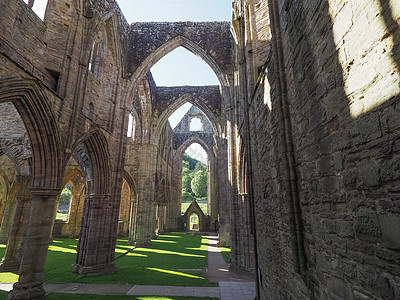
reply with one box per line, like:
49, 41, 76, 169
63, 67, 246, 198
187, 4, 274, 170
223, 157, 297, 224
0, 235, 256, 300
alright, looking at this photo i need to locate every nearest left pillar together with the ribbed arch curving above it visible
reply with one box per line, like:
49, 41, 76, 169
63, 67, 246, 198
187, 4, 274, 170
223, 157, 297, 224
0, 79, 63, 299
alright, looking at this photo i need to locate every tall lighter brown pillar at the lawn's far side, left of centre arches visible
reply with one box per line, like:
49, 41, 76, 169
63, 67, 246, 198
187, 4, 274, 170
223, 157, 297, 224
135, 144, 157, 247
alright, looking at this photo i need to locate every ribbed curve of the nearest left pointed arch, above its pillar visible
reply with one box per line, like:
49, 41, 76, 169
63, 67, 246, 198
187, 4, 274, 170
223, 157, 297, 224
0, 79, 63, 189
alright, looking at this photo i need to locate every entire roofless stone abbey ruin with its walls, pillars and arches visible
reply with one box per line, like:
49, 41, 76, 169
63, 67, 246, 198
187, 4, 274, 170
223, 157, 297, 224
0, 0, 400, 300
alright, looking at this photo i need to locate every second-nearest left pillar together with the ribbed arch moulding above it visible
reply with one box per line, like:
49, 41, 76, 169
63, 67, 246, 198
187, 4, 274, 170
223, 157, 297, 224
73, 130, 114, 274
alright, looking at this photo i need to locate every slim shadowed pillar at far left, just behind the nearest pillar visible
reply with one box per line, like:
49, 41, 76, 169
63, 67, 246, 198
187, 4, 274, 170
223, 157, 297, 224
0, 175, 31, 272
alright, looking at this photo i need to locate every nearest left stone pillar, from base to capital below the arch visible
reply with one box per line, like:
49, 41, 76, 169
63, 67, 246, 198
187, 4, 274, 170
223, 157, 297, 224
8, 188, 60, 300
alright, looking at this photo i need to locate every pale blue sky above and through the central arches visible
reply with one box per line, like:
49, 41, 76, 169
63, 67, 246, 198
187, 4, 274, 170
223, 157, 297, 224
117, 0, 232, 162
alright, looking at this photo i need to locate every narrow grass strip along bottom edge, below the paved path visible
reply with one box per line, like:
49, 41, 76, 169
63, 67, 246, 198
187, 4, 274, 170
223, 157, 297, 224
0, 292, 217, 300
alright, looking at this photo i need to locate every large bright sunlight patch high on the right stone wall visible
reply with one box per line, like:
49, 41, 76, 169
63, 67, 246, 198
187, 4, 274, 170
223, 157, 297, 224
329, 0, 400, 118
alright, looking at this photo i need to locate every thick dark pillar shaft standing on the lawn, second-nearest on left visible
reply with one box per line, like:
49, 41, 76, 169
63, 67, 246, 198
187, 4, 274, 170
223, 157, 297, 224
73, 194, 115, 275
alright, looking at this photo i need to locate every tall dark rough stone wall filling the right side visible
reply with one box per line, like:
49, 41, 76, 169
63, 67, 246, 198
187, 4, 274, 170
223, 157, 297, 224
235, 0, 400, 299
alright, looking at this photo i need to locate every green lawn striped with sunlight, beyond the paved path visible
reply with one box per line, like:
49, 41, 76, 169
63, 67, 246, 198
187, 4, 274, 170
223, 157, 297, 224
0, 233, 216, 286
